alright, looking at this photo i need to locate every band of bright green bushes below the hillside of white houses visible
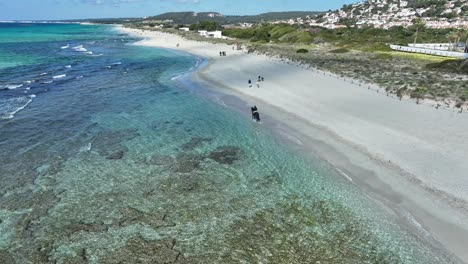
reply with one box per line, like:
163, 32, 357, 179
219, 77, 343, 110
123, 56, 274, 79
223, 24, 464, 52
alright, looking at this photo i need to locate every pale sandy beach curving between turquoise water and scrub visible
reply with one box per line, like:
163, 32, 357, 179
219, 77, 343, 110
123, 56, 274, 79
120, 28, 468, 263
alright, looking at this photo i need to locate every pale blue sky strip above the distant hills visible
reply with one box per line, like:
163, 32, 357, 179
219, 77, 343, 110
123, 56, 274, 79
0, 0, 358, 21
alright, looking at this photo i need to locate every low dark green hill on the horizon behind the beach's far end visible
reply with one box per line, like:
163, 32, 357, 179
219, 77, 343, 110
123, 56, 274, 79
145, 11, 321, 24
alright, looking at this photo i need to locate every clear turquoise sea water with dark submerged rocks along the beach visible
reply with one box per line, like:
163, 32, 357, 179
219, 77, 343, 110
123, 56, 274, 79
0, 24, 453, 263
